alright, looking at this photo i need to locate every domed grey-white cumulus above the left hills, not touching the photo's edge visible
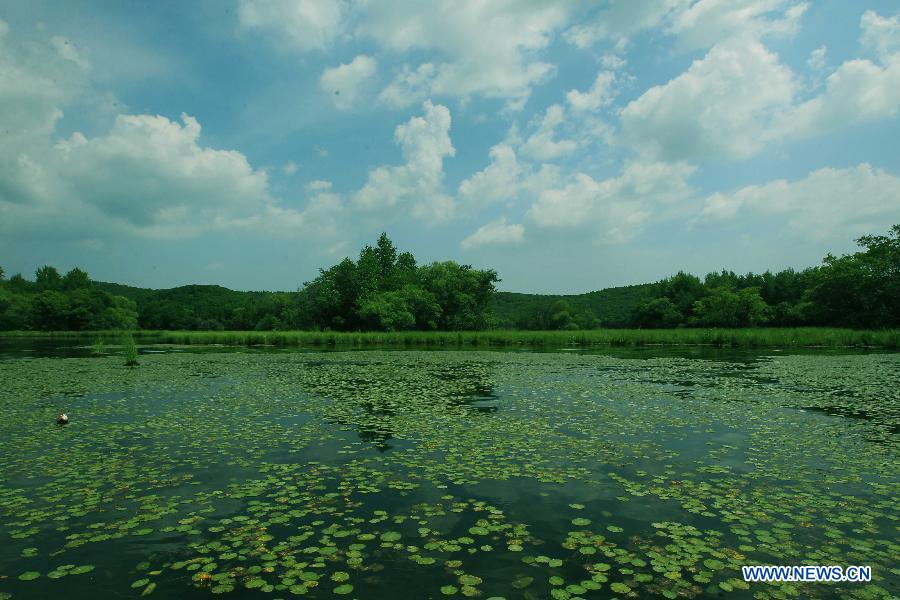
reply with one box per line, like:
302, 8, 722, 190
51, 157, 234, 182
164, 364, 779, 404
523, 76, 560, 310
53, 115, 271, 235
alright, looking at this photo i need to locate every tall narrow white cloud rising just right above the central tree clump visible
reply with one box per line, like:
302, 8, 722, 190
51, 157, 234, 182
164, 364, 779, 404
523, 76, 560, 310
354, 100, 456, 222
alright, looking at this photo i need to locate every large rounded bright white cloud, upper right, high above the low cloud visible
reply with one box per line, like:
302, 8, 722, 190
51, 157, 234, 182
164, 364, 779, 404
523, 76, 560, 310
621, 38, 797, 160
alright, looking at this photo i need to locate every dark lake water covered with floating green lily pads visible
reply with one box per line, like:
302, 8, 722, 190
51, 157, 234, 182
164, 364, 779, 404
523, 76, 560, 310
0, 340, 900, 600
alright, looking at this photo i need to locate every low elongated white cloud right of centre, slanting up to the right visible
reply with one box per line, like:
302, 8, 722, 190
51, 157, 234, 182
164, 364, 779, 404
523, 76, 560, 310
528, 162, 696, 243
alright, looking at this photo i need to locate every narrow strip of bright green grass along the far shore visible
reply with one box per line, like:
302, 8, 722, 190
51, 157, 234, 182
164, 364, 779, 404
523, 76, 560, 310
0, 327, 900, 349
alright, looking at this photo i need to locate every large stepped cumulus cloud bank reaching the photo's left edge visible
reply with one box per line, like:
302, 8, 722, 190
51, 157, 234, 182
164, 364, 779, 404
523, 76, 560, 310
0, 21, 342, 239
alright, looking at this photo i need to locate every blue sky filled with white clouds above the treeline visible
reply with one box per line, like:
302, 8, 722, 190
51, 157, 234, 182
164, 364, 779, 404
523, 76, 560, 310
0, 0, 900, 293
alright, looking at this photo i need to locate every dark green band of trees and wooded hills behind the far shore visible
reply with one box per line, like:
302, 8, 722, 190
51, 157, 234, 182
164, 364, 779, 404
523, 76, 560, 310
0, 225, 900, 331
